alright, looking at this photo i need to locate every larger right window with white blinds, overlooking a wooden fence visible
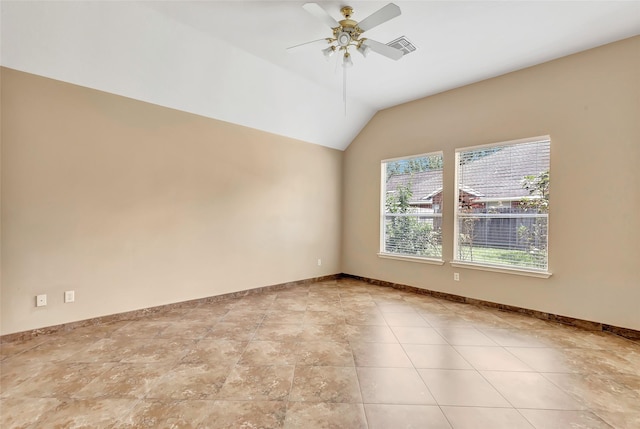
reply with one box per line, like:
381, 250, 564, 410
454, 136, 550, 271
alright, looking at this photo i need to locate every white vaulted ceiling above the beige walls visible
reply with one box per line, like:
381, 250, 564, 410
0, 0, 640, 149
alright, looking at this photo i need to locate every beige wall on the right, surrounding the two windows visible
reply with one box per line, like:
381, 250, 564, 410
342, 37, 640, 329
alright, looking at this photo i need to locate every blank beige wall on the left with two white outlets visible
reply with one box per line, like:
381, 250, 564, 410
0, 68, 342, 334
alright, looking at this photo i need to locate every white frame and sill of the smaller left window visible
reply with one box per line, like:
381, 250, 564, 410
377, 150, 445, 265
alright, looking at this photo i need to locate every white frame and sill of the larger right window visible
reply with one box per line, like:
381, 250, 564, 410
450, 135, 552, 278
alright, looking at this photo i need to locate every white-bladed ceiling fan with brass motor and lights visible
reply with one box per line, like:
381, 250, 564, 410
288, 3, 404, 68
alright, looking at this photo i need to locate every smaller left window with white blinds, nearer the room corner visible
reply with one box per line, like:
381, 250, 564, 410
380, 152, 443, 259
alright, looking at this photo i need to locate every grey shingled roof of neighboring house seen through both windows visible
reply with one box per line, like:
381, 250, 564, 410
387, 143, 549, 204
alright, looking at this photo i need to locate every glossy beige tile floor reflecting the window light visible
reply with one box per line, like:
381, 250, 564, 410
0, 279, 640, 429
